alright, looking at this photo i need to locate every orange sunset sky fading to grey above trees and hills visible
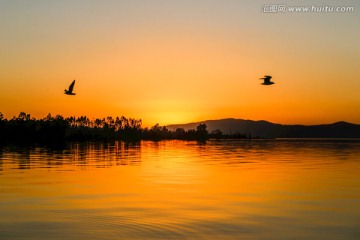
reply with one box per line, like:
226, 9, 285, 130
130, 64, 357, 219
0, 0, 360, 126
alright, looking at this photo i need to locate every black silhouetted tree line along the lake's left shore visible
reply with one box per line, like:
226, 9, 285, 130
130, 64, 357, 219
0, 112, 247, 142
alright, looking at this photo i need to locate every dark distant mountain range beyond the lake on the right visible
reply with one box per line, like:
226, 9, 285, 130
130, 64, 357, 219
166, 118, 360, 138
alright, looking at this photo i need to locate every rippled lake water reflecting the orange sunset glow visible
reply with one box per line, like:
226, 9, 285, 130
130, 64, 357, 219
0, 140, 360, 240
